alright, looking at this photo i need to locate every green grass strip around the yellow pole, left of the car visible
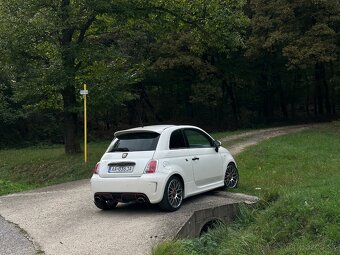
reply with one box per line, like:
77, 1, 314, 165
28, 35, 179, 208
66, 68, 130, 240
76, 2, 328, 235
0, 141, 109, 195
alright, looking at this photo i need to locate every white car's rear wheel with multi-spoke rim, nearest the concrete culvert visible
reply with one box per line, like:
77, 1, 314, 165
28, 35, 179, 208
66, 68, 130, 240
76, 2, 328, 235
159, 176, 184, 212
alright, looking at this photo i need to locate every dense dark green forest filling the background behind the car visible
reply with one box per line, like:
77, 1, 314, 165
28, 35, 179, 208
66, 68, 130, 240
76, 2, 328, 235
0, 0, 340, 153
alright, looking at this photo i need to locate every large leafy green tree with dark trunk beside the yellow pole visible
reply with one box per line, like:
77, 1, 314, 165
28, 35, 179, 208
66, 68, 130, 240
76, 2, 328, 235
0, 0, 247, 149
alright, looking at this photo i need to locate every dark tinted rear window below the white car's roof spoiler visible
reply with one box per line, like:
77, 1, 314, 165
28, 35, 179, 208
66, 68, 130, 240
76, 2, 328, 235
110, 132, 160, 152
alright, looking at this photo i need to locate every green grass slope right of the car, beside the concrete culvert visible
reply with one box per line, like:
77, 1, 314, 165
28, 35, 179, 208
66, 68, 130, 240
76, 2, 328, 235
153, 122, 340, 255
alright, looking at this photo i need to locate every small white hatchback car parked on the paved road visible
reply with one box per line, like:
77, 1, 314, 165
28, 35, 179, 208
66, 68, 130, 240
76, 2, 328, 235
91, 125, 239, 211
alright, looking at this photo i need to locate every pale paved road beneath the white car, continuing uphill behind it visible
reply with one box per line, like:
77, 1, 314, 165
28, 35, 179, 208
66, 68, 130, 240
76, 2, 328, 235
0, 126, 305, 255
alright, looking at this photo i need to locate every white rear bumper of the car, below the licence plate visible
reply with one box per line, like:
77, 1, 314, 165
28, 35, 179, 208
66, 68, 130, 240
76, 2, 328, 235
91, 173, 167, 204
